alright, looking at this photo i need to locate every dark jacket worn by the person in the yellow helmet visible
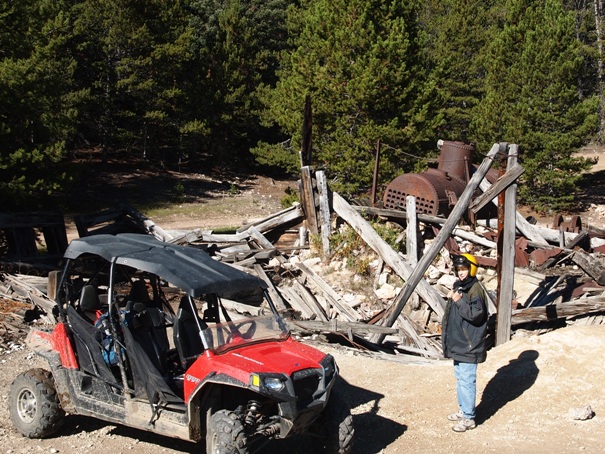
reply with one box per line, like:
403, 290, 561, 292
441, 277, 488, 363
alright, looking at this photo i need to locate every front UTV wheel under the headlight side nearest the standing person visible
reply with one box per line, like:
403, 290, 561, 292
309, 391, 355, 454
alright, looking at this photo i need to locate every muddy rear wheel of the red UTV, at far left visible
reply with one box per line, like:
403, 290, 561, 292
8, 369, 65, 438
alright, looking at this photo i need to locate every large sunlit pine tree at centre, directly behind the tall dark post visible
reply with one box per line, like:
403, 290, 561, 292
254, 0, 438, 193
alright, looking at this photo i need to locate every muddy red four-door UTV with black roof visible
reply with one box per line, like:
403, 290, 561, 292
9, 234, 353, 454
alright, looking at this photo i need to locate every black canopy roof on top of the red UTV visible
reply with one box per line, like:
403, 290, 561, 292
65, 233, 266, 298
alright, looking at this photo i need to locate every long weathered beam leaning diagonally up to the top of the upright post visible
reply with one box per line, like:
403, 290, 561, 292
373, 143, 500, 343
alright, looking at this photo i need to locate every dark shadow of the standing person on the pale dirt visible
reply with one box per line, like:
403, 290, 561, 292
476, 350, 540, 424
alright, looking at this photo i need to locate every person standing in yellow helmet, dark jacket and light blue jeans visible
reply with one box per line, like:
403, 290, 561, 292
441, 254, 488, 432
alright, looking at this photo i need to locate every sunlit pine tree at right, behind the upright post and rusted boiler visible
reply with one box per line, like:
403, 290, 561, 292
472, 0, 598, 210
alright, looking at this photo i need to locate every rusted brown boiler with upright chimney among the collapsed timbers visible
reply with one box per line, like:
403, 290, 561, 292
383, 141, 498, 216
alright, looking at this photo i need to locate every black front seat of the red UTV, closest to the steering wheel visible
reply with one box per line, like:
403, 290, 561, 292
173, 296, 208, 370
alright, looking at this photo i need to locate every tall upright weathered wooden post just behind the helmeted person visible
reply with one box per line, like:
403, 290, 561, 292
496, 145, 518, 345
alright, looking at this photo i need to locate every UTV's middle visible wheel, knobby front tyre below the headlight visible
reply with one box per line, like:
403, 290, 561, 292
206, 410, 248, 454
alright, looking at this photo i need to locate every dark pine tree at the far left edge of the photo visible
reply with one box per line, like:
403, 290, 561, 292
0, 0, 86, 210
